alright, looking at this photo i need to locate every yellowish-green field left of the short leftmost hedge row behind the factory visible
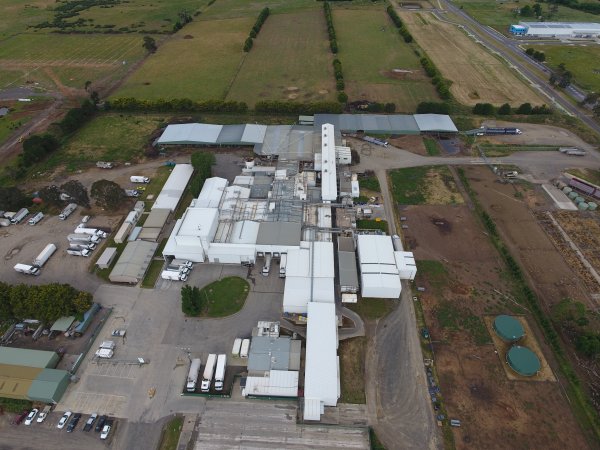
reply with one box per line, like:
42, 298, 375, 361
114, 18, 255, 101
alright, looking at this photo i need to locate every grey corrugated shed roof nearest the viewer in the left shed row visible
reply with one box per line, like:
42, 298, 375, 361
108, 241, 158, 283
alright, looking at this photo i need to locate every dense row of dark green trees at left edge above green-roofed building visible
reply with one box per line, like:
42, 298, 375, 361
0, 282, 92, 324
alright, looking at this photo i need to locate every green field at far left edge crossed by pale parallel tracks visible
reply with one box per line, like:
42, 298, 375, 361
0, 33, 145, 92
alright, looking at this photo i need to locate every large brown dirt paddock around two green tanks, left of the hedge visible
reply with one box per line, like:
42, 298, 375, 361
401, 199, 587, 449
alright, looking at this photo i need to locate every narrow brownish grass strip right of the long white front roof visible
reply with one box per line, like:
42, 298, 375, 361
339, 336, 367, 404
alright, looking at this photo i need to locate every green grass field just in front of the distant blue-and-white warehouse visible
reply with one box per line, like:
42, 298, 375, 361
534, 45, 600, 92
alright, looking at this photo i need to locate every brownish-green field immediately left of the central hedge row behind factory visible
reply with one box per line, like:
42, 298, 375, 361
226, 9, 335, 107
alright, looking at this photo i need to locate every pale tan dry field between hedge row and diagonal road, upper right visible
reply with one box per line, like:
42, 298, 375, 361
401, 12, 545, 105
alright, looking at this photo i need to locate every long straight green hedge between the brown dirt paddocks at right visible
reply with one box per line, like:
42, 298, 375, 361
458, 168, 600, 438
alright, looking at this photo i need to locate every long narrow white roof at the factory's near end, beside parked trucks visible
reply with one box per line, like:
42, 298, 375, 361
304, 302, 340, 420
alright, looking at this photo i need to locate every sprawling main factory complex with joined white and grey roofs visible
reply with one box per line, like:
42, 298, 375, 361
158, 115, 418, 421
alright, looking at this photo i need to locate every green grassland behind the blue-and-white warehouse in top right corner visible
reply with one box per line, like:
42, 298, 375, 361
456, 0, 598, 35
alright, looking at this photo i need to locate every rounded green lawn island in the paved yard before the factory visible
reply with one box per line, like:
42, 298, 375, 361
200, 277, 250, 317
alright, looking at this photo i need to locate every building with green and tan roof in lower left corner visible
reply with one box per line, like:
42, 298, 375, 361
0, 347, 69, 404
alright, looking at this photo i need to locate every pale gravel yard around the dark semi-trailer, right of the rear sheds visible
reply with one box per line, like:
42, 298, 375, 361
477, 120, 594, 151
